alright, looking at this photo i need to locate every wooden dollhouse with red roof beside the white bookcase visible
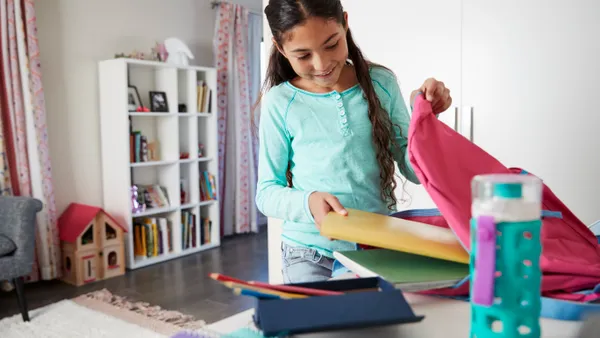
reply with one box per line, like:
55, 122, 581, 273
58, 203, 127, 286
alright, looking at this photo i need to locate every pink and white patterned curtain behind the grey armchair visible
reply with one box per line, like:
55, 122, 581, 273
0, 0, 61, 281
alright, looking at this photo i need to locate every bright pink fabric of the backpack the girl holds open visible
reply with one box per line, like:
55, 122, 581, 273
408, 95, 600, 301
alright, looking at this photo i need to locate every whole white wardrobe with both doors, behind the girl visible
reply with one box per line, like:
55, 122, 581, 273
264, 0, 600, 281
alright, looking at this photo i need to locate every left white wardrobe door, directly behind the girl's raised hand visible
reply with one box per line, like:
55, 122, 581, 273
342, 0, 461, 209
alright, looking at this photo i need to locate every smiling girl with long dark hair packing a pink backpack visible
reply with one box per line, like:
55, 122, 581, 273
256, 0, 452, 283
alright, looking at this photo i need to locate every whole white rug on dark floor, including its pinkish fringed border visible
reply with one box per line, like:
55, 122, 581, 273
0, 289, 220, 338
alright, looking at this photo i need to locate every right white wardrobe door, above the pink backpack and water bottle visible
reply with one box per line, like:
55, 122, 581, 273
462, 0, 600, 224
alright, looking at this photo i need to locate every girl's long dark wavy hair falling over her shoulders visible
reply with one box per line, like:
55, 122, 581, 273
252, 0, 404, 209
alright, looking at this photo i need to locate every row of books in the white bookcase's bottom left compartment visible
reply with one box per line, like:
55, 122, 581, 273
133, 217, 173, 259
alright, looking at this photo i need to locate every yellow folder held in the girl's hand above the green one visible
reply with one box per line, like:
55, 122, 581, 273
321, 209, 469, 263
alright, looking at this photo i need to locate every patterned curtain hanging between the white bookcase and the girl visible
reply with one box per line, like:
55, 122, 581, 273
213, 2, 257, 235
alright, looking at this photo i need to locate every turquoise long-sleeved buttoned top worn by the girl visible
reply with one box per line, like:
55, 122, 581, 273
256, 67, 419, 257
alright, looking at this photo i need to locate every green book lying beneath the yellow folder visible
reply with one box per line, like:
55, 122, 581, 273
334, 249, 469, 292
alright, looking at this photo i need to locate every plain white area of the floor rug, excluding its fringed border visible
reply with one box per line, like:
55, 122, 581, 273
0, 300, 169, 338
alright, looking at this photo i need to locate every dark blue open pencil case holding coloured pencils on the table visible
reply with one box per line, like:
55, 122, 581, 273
254, 278, 424, 336
